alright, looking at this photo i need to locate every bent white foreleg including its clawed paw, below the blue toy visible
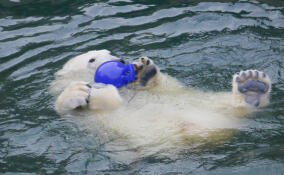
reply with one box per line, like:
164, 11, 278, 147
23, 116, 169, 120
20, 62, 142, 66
55, 81, 122, 112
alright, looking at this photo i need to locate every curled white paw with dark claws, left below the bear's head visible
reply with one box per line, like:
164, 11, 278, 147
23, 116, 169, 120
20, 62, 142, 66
56, 82, 90, 111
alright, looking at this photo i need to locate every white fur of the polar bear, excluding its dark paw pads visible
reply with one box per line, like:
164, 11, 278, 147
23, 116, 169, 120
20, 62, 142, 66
51, 51, 271, 159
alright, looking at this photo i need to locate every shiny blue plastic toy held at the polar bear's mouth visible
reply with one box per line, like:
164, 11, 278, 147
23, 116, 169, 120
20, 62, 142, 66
95, 61, 135, 88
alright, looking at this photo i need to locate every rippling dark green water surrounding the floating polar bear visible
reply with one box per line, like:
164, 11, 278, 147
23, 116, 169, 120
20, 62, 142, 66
0, 0, 284, 175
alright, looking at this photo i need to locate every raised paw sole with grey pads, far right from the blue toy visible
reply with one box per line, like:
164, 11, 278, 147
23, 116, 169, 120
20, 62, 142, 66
233, 70, 271, 107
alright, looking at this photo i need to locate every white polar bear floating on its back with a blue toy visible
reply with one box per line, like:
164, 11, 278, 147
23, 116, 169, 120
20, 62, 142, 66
51, 50, 271, 157
